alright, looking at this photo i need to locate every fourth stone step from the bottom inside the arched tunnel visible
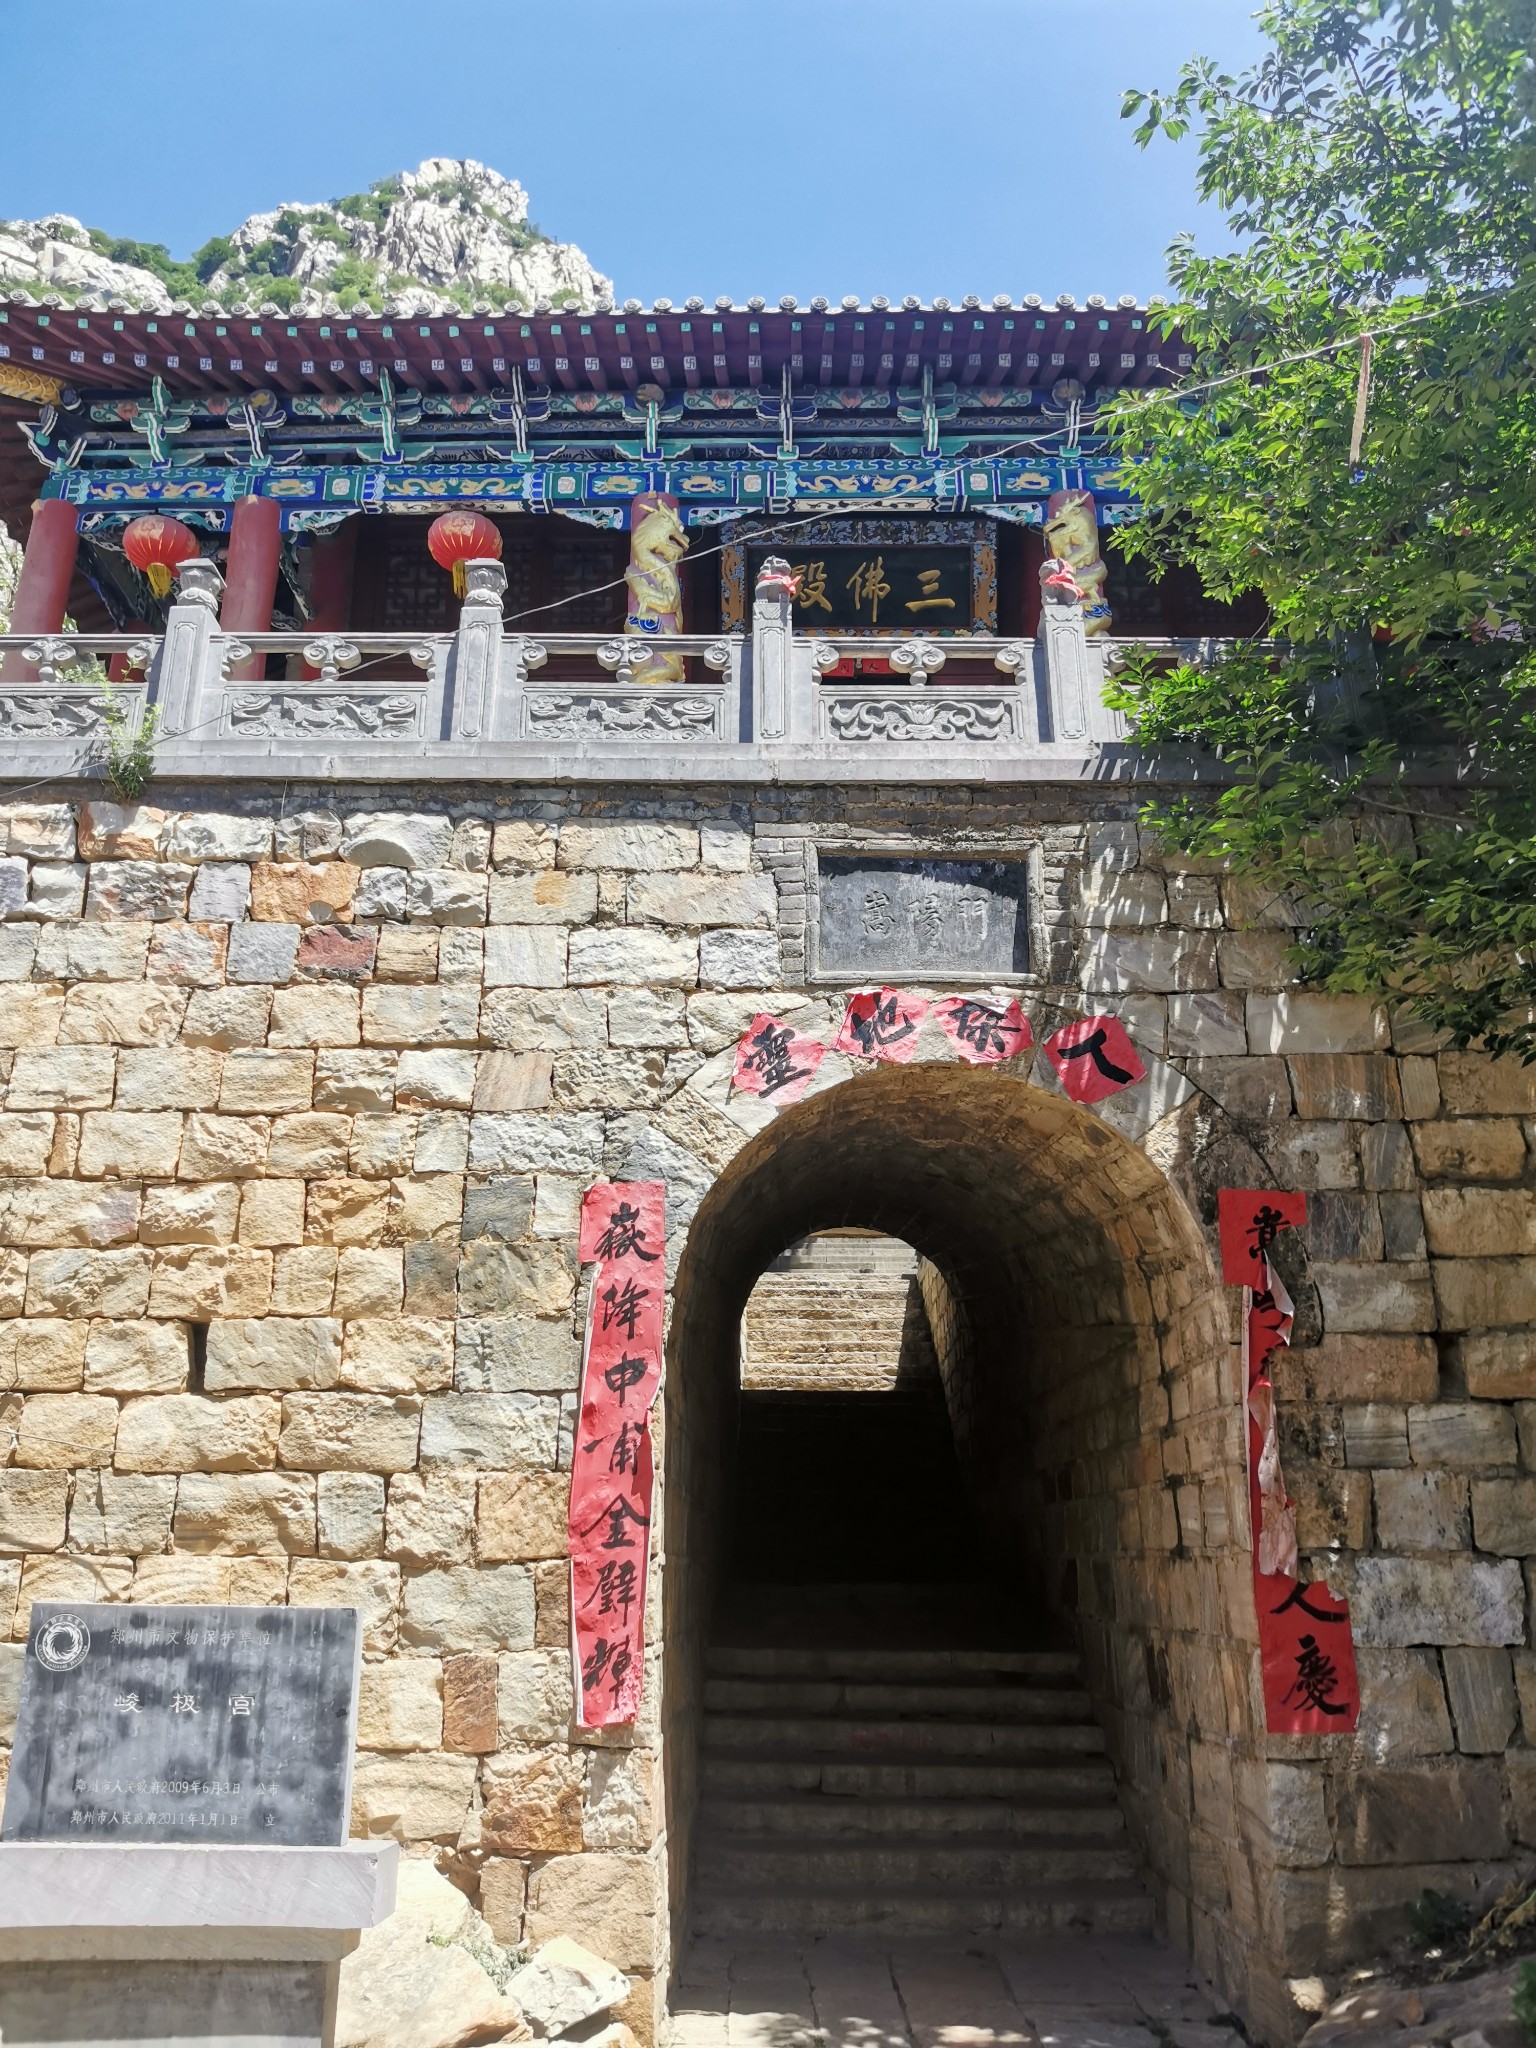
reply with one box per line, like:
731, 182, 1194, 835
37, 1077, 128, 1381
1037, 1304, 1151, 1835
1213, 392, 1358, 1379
702, 1749, 1114, 1800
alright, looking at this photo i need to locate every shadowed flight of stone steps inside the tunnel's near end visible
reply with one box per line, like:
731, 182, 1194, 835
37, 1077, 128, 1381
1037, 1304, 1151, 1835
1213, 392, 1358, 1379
690, 1645, 1153, 1939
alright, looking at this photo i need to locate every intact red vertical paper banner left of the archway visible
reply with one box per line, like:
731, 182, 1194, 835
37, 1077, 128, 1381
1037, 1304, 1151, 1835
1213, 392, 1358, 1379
567, 1180, 666, 1729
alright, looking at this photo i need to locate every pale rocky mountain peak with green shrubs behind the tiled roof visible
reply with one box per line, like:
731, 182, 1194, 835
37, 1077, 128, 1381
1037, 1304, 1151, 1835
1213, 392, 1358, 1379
0, 156, 612, 313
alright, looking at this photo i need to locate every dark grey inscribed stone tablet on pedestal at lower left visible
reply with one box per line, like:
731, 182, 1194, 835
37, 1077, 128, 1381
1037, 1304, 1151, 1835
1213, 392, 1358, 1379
0, 1599, 362, 1847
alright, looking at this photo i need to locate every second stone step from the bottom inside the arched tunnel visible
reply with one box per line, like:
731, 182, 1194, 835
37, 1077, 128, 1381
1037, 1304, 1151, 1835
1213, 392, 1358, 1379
694, 1831, 1137, 1892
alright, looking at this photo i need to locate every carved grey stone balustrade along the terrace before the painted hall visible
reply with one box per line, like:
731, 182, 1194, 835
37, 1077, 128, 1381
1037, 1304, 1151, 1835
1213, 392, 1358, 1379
0, 561, 1253, 780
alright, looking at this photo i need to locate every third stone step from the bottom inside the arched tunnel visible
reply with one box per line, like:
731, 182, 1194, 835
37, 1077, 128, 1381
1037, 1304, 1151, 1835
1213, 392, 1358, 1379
698, 1774, 1124, 1843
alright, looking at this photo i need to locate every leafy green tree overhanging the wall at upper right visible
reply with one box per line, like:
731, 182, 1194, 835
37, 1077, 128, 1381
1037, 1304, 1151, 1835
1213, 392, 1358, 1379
1106, 0, 1536, 1059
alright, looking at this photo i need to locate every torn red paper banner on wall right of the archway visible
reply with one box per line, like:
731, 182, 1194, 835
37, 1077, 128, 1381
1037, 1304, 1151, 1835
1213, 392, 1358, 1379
1217, 1188, 1360, 1735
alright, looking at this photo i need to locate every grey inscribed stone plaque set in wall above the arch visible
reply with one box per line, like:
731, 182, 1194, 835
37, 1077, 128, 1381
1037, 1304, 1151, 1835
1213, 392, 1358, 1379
817, 854, 1030, 981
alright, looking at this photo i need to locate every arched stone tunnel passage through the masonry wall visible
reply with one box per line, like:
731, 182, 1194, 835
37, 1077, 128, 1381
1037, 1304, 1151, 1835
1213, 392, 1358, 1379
664, 1067, 1262, 2015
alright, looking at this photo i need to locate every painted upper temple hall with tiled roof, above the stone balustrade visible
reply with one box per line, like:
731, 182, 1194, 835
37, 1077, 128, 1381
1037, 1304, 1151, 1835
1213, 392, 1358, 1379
0, 301, 1255, 674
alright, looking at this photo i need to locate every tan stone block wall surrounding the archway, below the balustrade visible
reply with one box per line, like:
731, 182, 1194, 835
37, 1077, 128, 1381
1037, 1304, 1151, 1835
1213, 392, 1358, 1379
0, 782, 1536, 2038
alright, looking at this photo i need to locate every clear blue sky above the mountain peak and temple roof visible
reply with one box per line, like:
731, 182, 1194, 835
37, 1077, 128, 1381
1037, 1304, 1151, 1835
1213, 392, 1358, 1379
0, 0, 1260, 301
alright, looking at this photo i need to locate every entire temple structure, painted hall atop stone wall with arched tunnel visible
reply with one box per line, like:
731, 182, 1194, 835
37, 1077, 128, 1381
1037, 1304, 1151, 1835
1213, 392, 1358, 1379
0, 295, 1536, 2048
